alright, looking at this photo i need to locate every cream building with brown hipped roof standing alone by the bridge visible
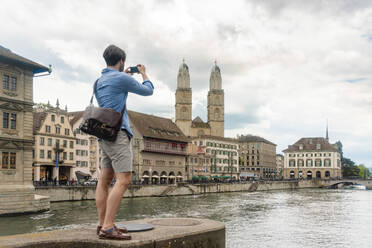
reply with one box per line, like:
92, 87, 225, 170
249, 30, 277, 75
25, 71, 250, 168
283, 137, 342, 179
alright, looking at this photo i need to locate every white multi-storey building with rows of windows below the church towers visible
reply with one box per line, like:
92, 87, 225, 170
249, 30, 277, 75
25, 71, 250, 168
188, 135, 239, 179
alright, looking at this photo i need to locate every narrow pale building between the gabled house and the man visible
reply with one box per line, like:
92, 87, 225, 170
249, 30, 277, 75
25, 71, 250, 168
69, 111, 101, 179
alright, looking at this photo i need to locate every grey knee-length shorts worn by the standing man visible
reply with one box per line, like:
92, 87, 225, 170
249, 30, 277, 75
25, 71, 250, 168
99, 130, 133, 173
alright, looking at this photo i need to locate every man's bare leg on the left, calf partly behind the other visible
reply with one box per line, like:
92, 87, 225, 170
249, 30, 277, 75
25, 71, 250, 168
96, 168, 115, 226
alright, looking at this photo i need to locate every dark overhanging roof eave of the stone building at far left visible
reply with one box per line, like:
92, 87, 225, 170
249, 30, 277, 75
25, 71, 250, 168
0, 45, 49, 74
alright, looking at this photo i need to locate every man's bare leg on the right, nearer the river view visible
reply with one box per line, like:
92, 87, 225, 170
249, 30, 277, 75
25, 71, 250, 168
102, 172, 132, 230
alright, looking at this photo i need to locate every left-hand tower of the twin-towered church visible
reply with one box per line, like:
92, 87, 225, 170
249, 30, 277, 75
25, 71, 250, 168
175, 60, 192, 136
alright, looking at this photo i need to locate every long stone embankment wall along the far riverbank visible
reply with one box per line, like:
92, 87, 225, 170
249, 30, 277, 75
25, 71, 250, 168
36, 180, 323, 202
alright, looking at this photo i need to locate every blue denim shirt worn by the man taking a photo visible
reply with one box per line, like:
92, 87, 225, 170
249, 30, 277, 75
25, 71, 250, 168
95, 68, 154, 137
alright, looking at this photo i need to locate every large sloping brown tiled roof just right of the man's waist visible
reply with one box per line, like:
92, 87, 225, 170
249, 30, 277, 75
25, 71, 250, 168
128, 110, 189, 142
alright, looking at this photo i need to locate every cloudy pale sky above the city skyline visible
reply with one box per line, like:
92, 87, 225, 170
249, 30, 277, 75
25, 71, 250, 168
0, 0, 372, 167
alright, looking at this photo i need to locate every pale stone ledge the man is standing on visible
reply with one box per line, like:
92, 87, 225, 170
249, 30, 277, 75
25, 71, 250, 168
0, 218, 225, 248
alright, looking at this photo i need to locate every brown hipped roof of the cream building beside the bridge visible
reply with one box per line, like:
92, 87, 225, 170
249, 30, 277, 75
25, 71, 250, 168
283, 137, 338, 152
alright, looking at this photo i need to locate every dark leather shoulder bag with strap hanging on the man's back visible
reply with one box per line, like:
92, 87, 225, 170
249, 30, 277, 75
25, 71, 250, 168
79, 79, 126, 142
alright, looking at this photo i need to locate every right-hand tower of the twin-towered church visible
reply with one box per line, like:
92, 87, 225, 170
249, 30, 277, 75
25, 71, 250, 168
208, 62, 225, 137
